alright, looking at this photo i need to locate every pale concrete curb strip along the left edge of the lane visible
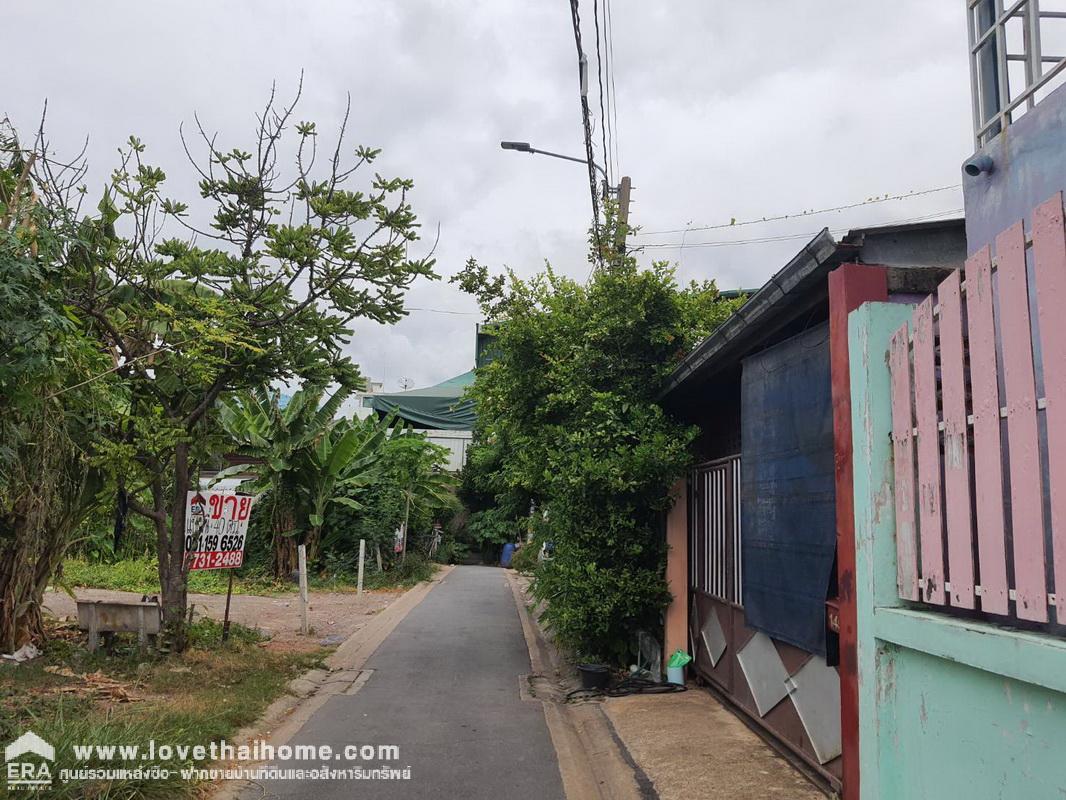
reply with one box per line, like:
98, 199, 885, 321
210, 564, 455, 800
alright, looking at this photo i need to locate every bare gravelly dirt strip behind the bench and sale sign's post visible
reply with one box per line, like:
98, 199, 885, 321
45, 589, 402, 651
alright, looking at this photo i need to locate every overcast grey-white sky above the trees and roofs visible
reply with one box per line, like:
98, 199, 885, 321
0, 0, 971, 389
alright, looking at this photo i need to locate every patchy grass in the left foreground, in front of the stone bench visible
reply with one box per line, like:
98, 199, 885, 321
0, 620, 327, 800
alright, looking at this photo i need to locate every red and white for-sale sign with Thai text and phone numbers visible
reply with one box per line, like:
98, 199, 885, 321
185, 492, 254, 570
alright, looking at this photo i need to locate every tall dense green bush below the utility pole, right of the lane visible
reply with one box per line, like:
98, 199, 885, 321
458, 222, 736, 661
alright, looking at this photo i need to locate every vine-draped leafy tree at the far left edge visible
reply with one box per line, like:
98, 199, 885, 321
0, 122, 115, 653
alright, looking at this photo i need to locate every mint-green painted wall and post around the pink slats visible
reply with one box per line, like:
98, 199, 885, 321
849, 303, 1066, 800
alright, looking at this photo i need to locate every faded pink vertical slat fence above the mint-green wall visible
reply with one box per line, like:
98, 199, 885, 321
889, 193, 1066, 624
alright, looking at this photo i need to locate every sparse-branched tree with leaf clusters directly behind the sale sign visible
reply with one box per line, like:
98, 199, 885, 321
55, 87, 433, 650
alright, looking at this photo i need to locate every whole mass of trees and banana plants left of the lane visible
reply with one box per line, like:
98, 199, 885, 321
0, 83, 456, 665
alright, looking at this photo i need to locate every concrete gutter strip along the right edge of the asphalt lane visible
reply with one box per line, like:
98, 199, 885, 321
507, 572, 658, 800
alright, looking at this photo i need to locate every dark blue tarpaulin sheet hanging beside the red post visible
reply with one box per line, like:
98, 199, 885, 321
741, 324, 837, 656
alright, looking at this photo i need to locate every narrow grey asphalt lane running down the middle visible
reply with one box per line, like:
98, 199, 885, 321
242, 566, 564, 800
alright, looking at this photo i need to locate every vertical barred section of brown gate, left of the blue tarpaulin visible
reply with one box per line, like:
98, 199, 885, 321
689, 455, 743, 605
